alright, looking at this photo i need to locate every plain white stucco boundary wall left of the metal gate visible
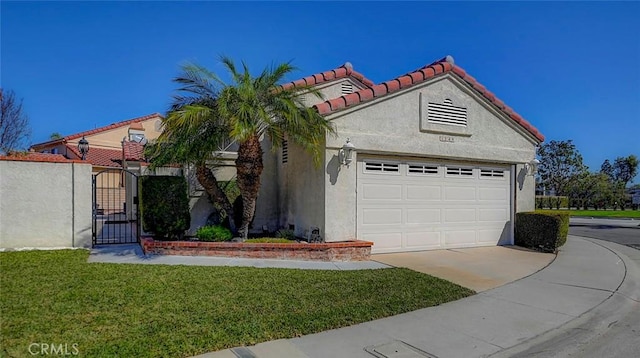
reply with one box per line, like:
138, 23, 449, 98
0, 161, 91, 248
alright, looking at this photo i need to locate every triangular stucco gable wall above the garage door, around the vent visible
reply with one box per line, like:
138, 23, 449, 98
327, 75, 536, 163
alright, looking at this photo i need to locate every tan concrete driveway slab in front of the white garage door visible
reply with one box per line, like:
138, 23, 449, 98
371, 246, 556, 292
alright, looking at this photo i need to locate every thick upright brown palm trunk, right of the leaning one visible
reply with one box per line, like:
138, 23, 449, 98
236, 135, 264, 240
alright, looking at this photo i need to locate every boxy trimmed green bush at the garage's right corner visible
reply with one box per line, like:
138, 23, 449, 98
515, 211, 570, 252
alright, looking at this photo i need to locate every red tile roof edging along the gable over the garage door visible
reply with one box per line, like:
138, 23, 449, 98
313, 56, 544, 142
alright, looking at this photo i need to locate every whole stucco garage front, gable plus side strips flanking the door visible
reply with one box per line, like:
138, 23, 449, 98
325, 75, 537, 241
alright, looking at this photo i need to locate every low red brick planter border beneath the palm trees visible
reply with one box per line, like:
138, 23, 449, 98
140, 237, 373, 261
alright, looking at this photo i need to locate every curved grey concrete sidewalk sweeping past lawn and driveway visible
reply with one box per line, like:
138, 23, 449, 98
198, 236, 640, 358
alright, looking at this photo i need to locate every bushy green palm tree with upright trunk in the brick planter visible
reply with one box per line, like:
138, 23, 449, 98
150, 57, 335, 239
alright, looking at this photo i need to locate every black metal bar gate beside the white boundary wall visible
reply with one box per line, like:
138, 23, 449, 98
92, 168, 140, 246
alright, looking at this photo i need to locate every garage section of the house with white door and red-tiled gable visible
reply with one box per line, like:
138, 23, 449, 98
252, 56, 544, 253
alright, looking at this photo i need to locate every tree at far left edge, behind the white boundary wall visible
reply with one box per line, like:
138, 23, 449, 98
0, 88, 31, 154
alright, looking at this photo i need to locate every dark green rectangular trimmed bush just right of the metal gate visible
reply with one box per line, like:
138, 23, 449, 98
140, 176, 191, 240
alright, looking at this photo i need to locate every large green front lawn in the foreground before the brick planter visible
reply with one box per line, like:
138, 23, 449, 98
0, 250, 473, 357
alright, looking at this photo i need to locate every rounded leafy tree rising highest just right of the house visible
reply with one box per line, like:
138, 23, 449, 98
538, 140, 587, 195
